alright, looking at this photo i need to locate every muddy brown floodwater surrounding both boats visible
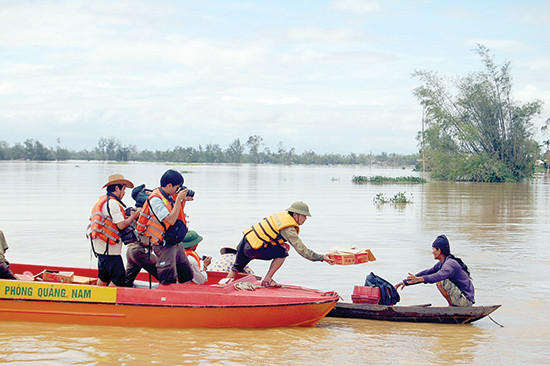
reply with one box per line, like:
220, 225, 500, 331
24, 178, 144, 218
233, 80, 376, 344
0, 162, 550, 365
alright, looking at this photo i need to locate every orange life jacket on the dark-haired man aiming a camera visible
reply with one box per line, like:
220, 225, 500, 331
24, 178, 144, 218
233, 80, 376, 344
136, 187, 187, 245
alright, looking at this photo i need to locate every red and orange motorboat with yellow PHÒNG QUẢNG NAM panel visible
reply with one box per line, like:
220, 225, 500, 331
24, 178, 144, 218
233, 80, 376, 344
0, 263, 339, 328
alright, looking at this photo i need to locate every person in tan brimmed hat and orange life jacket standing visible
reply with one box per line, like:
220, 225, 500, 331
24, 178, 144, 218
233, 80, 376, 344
87, 174, 138, 286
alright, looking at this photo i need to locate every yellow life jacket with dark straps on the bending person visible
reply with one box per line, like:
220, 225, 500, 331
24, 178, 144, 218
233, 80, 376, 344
243, 211, 300, 249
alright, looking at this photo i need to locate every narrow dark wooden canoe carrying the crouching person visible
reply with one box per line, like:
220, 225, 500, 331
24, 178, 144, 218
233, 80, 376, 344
327, 302, 500, 324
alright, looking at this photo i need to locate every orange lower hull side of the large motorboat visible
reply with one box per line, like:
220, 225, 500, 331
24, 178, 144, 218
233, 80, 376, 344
0, 300, 334, 328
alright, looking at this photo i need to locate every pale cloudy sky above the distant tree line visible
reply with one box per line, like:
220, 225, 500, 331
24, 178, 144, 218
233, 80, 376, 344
0, 0, 550, 155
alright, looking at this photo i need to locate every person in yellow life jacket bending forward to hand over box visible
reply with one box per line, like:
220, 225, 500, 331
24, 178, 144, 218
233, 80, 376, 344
227, 201, 334, 287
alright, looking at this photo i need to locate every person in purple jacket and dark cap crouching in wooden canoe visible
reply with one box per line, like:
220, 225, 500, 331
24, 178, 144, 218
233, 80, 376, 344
395, 235, 475, 306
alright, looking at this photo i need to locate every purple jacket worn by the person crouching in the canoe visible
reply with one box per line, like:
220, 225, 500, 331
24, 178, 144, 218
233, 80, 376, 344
416, 257, 475, 303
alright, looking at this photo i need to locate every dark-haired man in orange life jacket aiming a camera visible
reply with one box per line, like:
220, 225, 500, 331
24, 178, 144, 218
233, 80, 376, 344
136, 169, 194, 285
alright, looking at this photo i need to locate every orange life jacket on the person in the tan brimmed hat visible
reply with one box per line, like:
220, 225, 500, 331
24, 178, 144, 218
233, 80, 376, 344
86, 194, 126, 245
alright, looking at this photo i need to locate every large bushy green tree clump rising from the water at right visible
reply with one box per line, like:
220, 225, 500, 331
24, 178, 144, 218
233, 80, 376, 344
413, 45, 542, 182
